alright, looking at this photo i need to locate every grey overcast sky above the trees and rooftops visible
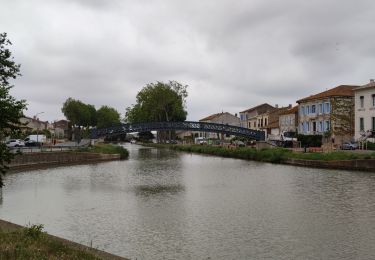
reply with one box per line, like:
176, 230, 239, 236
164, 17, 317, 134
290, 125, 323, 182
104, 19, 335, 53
0, 0, 375, 121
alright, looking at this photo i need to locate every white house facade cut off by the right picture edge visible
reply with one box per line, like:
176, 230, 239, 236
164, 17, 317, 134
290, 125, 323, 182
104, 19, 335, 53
354, 79, 375, 141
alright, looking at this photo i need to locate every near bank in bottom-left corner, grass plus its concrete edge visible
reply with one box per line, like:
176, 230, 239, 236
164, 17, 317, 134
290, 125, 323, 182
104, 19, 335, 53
0, 220, 125, 260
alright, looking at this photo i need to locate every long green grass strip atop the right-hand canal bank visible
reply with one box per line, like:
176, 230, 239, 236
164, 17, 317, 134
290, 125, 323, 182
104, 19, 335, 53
145, 144, 375, 163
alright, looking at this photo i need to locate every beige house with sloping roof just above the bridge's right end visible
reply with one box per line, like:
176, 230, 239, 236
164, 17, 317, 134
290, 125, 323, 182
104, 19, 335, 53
240, 103, 274, 129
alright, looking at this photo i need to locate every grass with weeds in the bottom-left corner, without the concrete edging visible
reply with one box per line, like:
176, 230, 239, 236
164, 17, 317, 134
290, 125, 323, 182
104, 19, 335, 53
0, 225, 100, 259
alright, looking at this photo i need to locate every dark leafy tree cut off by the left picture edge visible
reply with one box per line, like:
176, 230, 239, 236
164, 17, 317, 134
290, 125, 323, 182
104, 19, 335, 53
0, 33, 26, 187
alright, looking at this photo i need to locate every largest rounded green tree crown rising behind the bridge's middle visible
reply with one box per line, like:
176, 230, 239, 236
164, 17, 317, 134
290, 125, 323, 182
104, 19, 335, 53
125, 81, 188, 123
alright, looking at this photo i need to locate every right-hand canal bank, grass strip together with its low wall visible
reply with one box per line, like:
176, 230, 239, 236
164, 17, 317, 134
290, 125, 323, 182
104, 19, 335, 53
145, 144, 375, 172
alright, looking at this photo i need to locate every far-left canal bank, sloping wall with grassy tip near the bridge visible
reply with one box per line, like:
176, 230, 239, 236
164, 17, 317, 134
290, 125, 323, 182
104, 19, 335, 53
8, 144, 129, 171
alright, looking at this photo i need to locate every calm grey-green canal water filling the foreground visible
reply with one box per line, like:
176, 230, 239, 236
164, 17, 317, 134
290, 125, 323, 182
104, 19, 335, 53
0, 145, 375, 259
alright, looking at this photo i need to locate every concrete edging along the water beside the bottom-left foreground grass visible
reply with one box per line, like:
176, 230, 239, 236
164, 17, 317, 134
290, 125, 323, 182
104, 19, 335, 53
0, 219, 127, 260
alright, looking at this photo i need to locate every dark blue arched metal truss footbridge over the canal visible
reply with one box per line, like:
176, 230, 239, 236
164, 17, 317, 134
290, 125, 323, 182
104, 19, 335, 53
91, 121, 265, 141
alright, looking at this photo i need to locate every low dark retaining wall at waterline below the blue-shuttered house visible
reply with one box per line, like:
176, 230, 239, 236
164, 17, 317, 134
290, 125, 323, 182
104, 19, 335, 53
284, 158, 375, 172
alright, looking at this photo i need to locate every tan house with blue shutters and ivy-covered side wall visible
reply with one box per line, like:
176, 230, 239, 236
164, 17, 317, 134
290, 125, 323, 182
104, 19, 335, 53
297, 85, 358, 145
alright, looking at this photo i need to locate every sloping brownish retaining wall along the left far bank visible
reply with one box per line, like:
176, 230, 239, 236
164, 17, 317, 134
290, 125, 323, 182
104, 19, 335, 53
8, 151, 120, 171
